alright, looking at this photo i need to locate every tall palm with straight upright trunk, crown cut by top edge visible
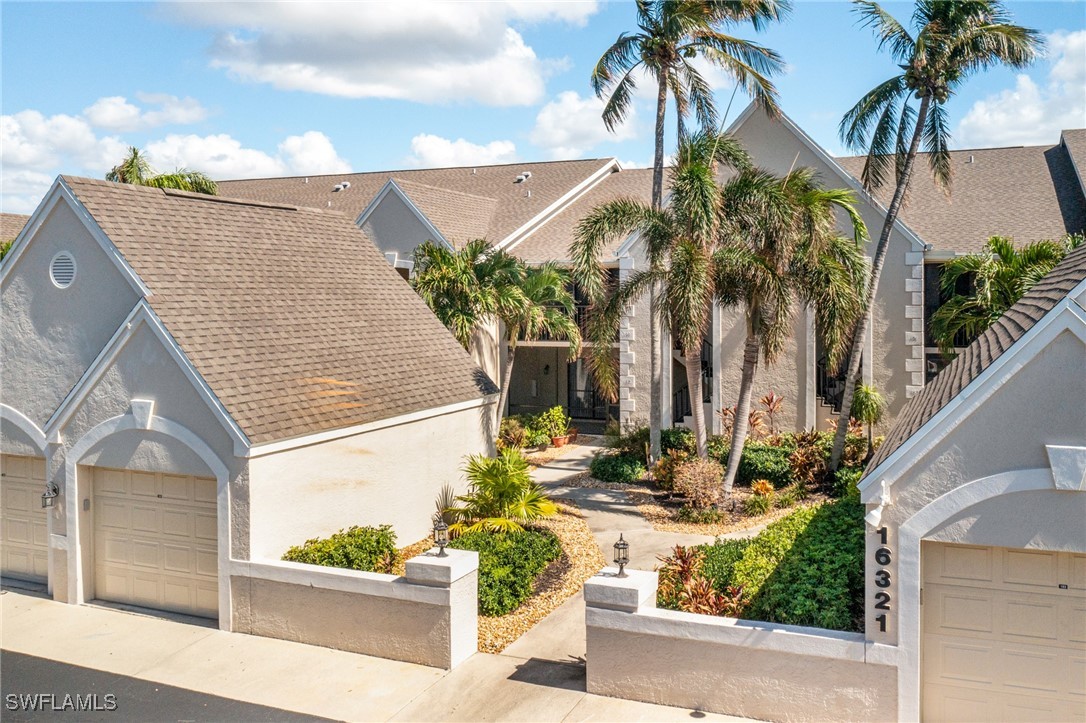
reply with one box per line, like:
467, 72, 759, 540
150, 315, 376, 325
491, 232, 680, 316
592, 0, 791, 459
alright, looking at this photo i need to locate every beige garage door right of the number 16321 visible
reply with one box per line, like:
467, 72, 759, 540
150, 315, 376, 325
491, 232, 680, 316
921, 543, 1086, 721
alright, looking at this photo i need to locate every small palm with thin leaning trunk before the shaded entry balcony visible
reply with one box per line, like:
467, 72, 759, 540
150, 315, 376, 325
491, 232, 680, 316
497, 263, 581, 415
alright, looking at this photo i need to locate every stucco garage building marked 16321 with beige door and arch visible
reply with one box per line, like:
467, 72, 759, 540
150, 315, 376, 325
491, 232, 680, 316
859, 246, 1086, 721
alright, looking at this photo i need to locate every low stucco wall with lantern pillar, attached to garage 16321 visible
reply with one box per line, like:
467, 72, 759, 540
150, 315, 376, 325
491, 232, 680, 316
585, 570, 897, 721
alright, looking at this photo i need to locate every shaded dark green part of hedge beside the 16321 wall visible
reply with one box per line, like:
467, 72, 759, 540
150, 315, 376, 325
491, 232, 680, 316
747, 499, 863, 632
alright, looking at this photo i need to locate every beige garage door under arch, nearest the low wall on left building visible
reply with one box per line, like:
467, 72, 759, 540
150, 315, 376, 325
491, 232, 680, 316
93, 468, 218, 618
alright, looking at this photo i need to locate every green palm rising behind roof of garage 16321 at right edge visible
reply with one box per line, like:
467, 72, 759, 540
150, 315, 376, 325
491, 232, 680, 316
932, 236, 1083, 357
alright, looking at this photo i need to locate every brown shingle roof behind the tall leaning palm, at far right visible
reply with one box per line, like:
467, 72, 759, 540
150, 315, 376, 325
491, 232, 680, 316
837, 137, 1086, 253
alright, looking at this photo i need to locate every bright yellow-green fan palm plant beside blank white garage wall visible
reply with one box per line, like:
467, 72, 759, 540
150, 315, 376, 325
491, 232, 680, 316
443, 447, 558, 534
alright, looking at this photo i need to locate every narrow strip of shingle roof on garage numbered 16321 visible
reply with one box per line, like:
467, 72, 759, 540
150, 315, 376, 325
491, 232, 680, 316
864, 245, 1086, 477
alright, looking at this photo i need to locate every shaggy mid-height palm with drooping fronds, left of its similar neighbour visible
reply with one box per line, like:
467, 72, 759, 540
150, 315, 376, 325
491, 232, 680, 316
570, 132, 750, 458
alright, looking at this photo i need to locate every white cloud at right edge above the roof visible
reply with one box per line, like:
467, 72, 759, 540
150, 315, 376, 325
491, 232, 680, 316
955, 30, 1086, 148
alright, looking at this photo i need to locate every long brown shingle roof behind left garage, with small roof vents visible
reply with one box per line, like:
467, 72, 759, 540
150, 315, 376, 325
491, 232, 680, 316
218, 158, 614, 243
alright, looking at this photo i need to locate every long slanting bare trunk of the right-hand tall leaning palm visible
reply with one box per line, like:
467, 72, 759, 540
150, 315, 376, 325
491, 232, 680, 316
830, 94, 932, 472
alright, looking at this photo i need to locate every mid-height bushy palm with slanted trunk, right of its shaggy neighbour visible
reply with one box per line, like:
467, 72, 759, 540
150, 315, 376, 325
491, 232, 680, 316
718, 168, 867, 498
